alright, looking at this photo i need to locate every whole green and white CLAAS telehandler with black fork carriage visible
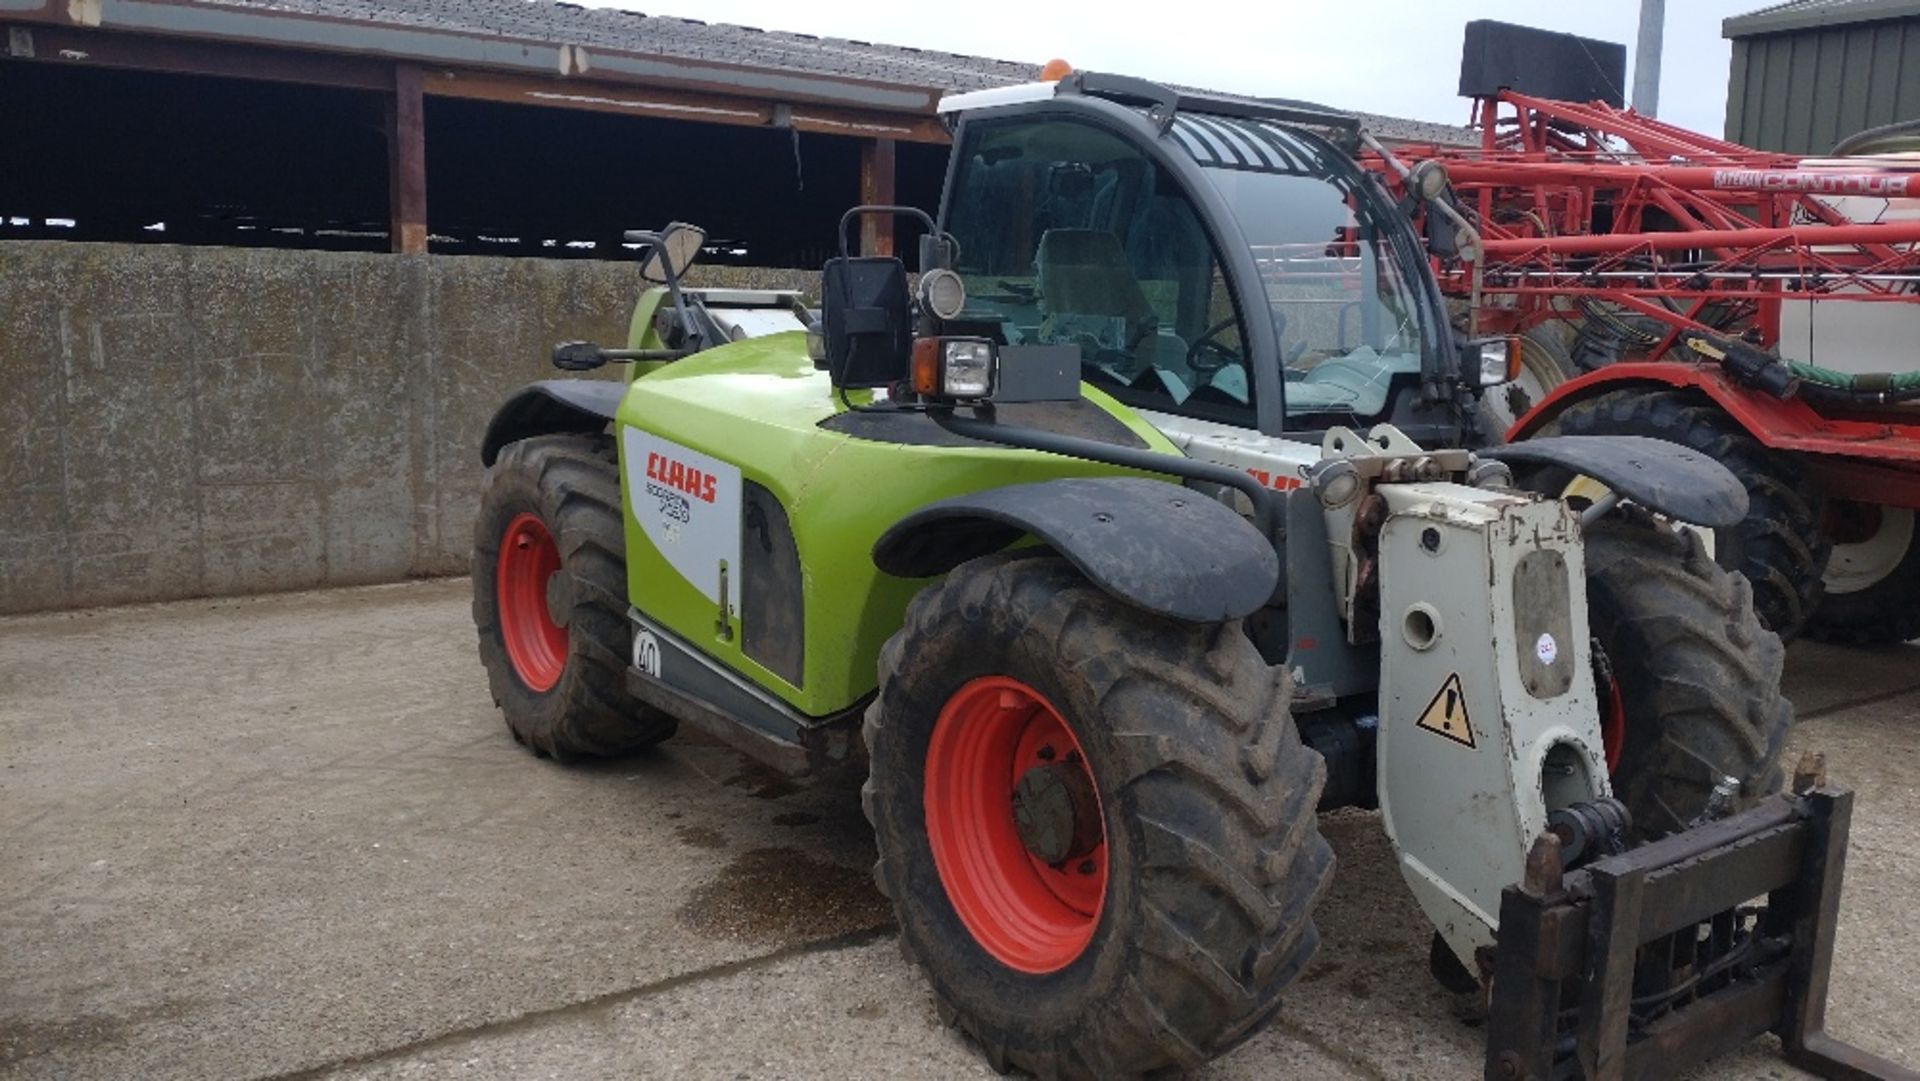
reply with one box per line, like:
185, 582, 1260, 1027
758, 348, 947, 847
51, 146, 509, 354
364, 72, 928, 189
474, 75, 1897, 1079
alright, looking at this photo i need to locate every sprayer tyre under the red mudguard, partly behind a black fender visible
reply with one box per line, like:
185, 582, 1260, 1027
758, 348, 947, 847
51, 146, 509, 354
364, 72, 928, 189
1542, 390, 1828, 639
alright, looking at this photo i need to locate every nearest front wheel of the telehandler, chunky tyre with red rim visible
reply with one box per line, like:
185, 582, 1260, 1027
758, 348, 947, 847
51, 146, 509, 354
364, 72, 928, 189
862, 555, 1332, 1079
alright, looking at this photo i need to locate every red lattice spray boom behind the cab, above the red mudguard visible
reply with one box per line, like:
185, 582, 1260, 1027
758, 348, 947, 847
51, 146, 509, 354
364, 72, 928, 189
1367, 90, 1920, 351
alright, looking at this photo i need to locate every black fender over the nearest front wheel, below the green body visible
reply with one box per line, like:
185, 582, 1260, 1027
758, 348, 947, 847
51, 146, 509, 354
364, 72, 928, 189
874, 476, 1281, 622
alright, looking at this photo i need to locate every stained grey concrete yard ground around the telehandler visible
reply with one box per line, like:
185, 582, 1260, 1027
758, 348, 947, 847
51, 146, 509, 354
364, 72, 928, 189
0, 580, 1920, 1079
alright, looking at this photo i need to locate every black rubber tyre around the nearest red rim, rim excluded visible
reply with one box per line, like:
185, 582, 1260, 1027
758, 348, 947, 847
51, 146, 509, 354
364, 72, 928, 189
862, 553, 1332, 1079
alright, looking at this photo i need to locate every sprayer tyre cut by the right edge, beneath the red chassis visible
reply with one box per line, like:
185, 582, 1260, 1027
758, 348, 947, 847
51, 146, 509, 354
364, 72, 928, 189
1807, 501, 1920, 645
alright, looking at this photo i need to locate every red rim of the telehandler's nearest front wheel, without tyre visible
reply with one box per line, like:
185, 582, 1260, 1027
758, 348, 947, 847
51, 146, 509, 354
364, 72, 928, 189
925, 676, 1108, 973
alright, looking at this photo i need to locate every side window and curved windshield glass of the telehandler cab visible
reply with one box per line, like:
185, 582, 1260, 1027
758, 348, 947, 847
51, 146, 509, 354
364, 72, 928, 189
945, 115, 1421, 426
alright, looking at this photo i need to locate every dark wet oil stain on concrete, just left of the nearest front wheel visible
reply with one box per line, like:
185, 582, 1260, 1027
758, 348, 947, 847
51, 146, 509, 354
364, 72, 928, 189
678, 849, 893, 943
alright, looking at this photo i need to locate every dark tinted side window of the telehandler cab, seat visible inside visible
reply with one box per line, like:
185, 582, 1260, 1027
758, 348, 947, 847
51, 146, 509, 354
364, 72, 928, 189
945, 119, 1254, 428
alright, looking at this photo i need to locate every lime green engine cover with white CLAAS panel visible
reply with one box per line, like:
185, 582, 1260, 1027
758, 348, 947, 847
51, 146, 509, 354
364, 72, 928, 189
616, 330, 1177, 716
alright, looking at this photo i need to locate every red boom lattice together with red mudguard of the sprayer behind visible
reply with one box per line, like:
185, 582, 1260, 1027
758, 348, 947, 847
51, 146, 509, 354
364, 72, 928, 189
1363, 90, 1920, 509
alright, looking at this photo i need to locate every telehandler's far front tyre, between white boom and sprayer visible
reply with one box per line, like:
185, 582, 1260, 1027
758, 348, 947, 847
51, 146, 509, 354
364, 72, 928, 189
1586, 509, 1793, 839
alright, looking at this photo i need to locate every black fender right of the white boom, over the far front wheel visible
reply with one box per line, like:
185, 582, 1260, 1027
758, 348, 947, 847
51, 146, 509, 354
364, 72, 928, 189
1476, 436, 1747, 530
